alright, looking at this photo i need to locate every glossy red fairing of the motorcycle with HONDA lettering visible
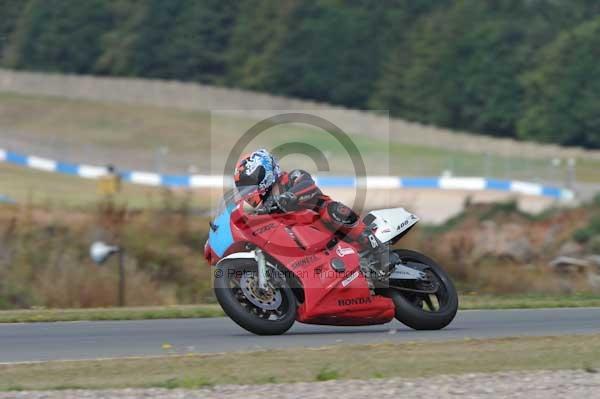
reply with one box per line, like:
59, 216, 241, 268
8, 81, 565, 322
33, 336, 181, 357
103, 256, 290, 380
216, 206, 394, 325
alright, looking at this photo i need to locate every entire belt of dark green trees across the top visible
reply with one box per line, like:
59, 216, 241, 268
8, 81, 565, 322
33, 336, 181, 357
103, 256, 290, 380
0, 0, 600, 148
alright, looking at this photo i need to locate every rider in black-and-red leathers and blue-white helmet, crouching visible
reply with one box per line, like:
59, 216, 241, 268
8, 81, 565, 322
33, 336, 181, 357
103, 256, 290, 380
234, 149, 391, 276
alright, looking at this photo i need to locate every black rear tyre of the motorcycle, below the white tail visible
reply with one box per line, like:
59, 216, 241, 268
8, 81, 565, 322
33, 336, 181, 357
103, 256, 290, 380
386, 249, 458, 330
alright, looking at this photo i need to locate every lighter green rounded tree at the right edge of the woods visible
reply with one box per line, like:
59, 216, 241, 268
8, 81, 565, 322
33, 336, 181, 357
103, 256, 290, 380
518, 17, 600, 148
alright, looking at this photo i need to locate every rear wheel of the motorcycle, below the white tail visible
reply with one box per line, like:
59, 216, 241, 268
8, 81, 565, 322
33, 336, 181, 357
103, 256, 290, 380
386, 249, 458, 330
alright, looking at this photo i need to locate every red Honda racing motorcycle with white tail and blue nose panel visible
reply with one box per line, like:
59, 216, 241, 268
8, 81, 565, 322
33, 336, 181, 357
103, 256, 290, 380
204, 193, 458, 335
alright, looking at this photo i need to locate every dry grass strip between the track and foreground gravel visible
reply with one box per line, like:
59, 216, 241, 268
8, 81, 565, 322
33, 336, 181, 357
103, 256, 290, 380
0, 335, 600, 390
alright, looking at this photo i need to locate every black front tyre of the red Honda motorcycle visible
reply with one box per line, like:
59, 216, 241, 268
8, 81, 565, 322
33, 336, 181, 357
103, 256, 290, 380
214, 259, 298, 335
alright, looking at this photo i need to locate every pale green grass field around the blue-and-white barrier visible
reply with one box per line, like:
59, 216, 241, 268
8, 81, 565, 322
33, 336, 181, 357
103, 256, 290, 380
0, 93, 600, 205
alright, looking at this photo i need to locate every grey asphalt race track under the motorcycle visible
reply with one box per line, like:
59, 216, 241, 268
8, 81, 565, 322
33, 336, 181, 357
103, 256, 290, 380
0, 308, 600, 363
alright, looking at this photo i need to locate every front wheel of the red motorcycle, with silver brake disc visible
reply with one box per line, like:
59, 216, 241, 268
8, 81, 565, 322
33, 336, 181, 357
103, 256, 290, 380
214, 259, 297, 335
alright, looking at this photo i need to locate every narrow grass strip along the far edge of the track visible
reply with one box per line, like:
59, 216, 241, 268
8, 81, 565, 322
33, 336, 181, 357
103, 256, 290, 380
0, 294, 600, 323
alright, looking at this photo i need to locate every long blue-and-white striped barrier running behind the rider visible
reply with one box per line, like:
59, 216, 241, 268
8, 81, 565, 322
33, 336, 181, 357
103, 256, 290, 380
0, 149, 573, 200
